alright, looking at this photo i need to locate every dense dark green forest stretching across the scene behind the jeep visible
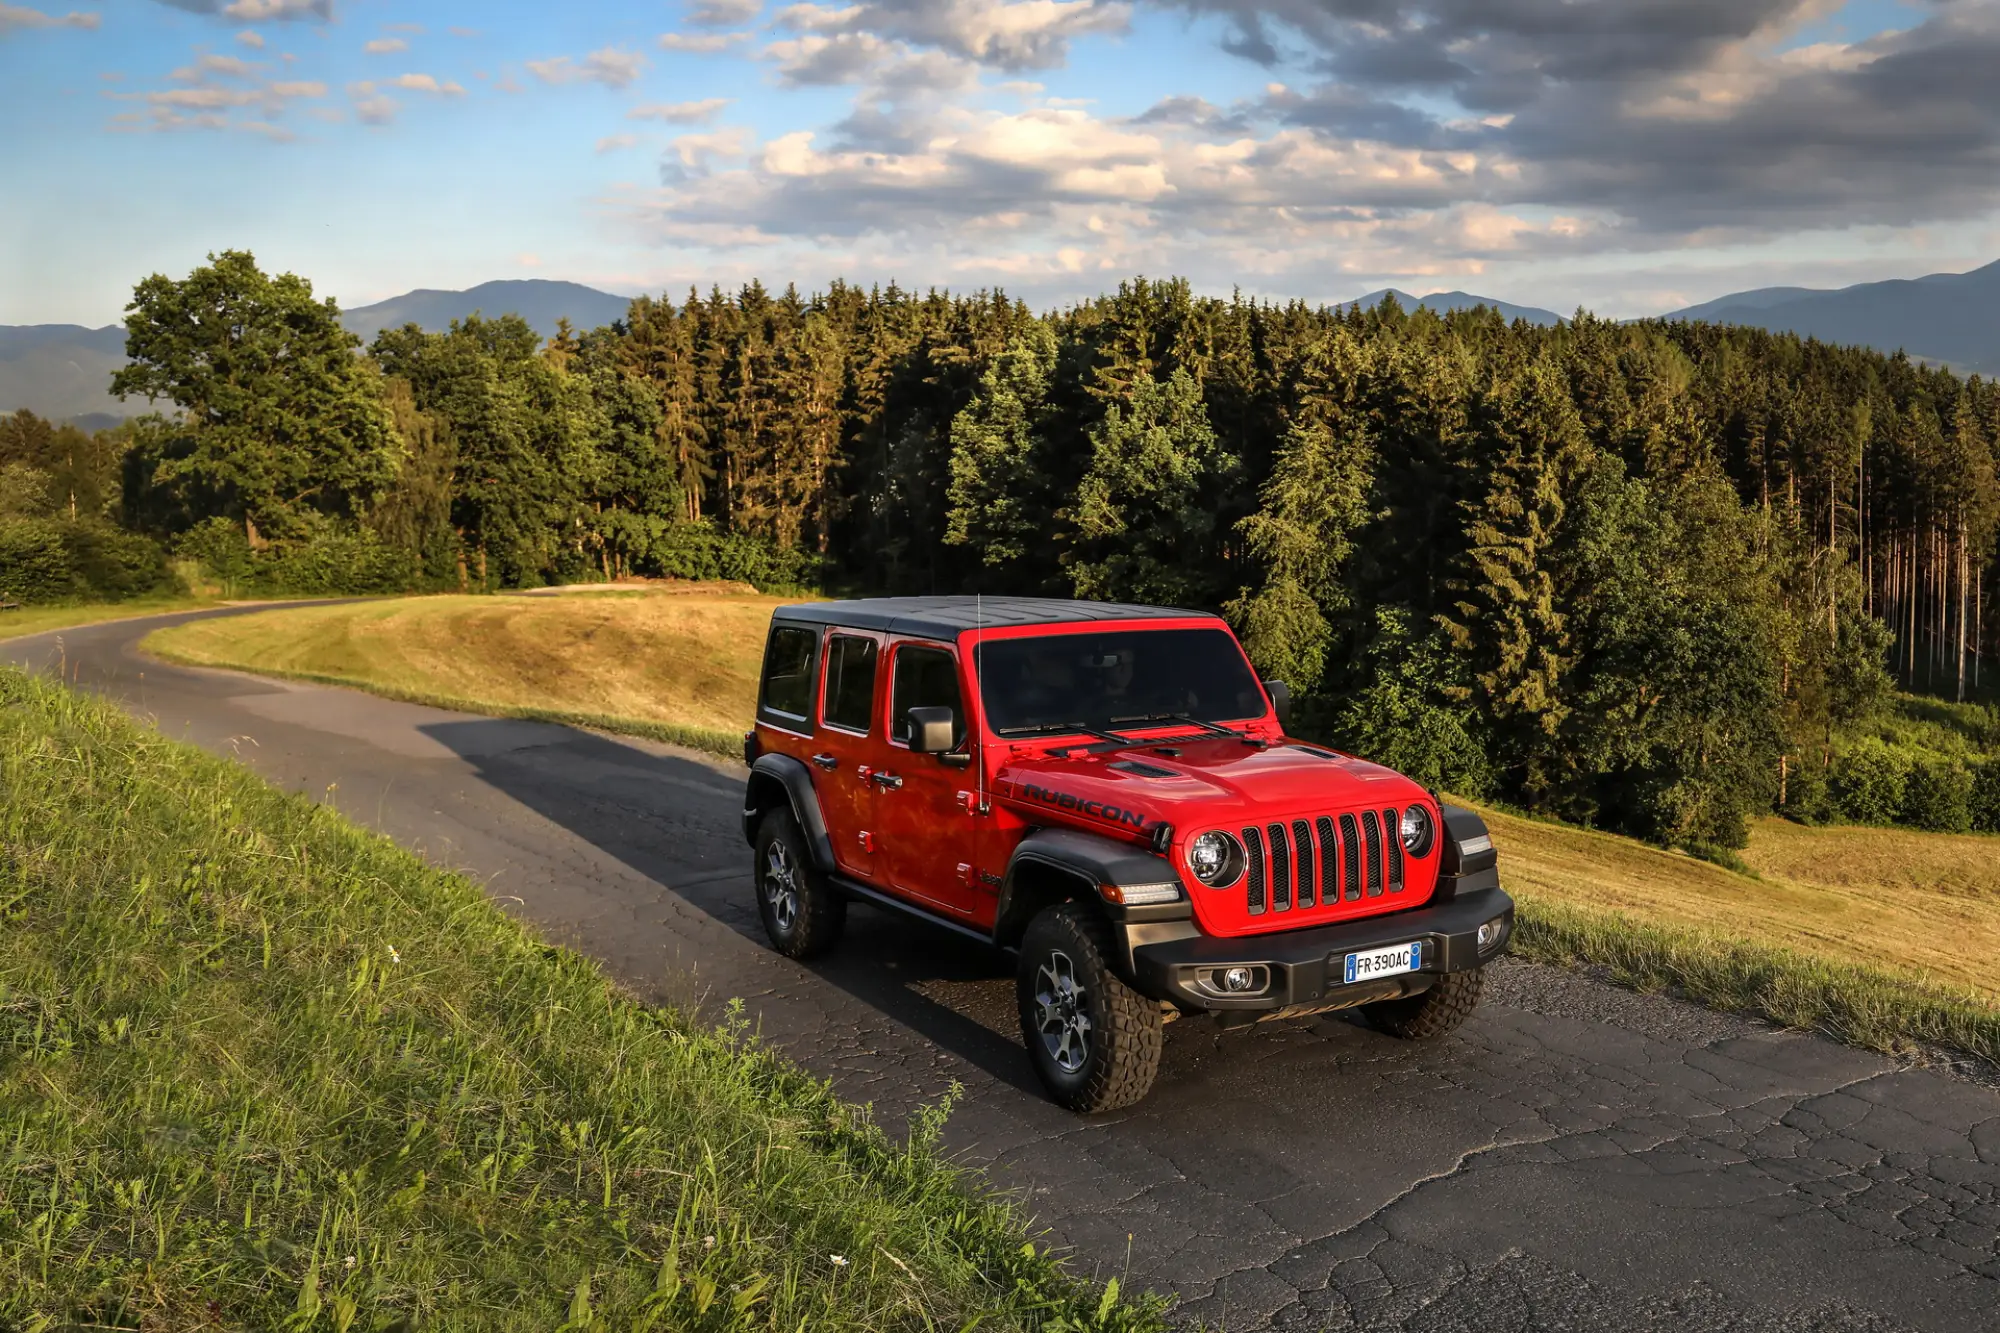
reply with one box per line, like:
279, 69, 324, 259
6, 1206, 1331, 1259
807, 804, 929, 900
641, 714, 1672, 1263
0, 252, 2000, 855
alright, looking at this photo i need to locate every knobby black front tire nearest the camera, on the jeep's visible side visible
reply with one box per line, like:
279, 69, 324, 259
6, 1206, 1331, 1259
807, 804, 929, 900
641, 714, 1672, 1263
1014, 903, 1166, 1115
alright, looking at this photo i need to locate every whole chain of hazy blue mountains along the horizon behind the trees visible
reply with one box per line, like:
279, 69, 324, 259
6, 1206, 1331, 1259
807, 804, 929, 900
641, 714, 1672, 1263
0, 262, 2000, 428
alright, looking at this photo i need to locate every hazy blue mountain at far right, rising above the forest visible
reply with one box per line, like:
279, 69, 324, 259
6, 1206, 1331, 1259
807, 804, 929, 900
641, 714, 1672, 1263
1666, 262, 2000, 374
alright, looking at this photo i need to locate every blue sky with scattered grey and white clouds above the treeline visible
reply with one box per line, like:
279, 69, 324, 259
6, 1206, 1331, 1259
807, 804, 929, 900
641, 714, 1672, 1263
0, 0, 2000, 324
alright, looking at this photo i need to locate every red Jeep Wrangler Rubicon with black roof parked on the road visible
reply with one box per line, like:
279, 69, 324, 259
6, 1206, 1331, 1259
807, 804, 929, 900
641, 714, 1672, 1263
744, 596, 1514, 1111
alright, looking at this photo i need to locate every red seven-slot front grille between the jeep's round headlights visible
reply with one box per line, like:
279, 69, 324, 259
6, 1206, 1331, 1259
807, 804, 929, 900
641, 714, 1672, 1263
1242, 809, 1404, 917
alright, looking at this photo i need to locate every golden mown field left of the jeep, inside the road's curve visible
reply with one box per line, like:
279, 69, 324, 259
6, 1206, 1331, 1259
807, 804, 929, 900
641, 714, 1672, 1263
146, 584, 798, 755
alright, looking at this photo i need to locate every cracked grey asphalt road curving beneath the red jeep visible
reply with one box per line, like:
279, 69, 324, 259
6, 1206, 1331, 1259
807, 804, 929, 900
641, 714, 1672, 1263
0, 616, 2000, 1333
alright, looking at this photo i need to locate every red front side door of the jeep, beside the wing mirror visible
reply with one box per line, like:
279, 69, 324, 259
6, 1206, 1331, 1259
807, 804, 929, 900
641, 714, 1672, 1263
876, 640, 996, 925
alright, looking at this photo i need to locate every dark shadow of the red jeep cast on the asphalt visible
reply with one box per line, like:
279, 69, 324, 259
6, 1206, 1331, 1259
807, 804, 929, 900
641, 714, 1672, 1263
420, 719, 1034, 1091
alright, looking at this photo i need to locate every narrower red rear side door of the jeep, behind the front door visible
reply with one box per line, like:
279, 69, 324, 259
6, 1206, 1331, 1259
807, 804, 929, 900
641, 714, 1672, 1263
812, 630, 882, 881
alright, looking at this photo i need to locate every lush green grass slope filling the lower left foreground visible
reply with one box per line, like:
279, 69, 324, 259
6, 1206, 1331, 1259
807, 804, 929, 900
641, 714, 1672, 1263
0, 669, 1160, 1333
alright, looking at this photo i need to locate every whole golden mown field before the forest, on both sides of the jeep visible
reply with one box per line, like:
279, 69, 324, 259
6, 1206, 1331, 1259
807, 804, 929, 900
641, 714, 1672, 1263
146, 590, 2000, 1051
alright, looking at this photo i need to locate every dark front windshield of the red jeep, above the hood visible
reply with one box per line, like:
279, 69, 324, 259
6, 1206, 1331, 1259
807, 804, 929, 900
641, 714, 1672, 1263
976, 628, 1264, 735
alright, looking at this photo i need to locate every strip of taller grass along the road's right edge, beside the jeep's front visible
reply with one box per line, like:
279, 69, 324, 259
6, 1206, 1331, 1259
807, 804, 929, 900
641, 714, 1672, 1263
1514, 895, 2000, 1065
